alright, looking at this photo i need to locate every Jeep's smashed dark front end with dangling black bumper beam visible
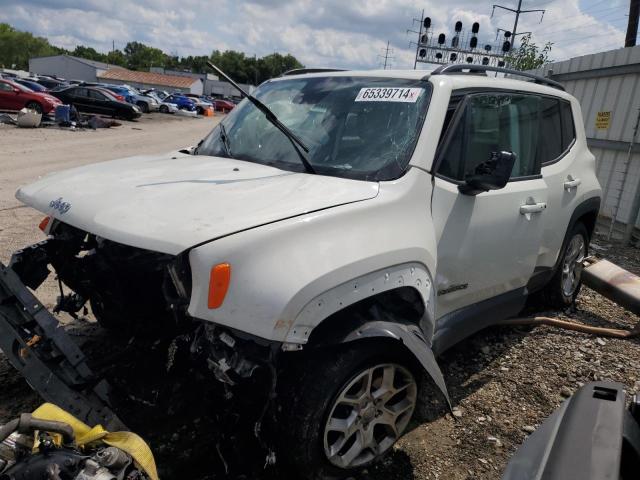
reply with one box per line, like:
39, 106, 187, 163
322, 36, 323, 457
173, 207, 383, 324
0, 222, 280, 474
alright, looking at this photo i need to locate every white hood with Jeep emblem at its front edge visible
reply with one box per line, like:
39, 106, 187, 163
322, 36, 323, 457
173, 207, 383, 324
16, 152, 378, 255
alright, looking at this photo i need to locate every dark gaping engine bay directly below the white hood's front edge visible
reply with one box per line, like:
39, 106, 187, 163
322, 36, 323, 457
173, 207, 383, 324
10, 222, 182, 330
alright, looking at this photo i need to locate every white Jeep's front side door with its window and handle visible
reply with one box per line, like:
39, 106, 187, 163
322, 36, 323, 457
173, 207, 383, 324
432, 92, 547, 317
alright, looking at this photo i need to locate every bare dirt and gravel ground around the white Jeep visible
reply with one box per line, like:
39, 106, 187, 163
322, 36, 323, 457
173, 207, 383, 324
0, 115, 640, 480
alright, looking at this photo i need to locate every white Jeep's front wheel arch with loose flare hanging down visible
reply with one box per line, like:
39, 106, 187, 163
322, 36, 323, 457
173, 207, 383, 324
287, 263, 451, 406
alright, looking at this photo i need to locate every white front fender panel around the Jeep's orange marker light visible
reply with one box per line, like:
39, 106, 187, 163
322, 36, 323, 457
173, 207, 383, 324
182, 168, 437, 345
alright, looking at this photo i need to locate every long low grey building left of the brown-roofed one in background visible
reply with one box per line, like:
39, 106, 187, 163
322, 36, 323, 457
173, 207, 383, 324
29, 55, 121, 82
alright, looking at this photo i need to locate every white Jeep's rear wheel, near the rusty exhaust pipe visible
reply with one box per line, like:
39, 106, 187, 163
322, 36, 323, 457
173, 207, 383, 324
541, 222, 589, 309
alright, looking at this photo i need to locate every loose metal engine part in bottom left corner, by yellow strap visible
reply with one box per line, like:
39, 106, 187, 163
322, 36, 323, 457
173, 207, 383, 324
0, 414, 149, 480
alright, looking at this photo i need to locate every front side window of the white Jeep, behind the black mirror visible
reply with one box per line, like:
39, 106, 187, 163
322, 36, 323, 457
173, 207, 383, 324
438, 93, 541, 181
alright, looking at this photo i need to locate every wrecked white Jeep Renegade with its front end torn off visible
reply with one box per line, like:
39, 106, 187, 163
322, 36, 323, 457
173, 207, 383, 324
12, 66, 601, 475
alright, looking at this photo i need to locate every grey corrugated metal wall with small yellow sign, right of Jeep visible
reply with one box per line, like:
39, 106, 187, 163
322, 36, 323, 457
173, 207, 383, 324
534, 46, 640, 238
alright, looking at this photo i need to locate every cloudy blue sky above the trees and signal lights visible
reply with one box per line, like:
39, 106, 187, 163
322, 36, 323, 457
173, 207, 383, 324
0, 0, 628, 69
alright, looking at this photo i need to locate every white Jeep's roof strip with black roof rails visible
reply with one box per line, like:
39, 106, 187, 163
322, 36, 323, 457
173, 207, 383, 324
269, 70, 571, 98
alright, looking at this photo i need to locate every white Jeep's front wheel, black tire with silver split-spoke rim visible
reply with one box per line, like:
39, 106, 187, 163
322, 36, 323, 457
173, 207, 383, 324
280, 340, 418, 478
